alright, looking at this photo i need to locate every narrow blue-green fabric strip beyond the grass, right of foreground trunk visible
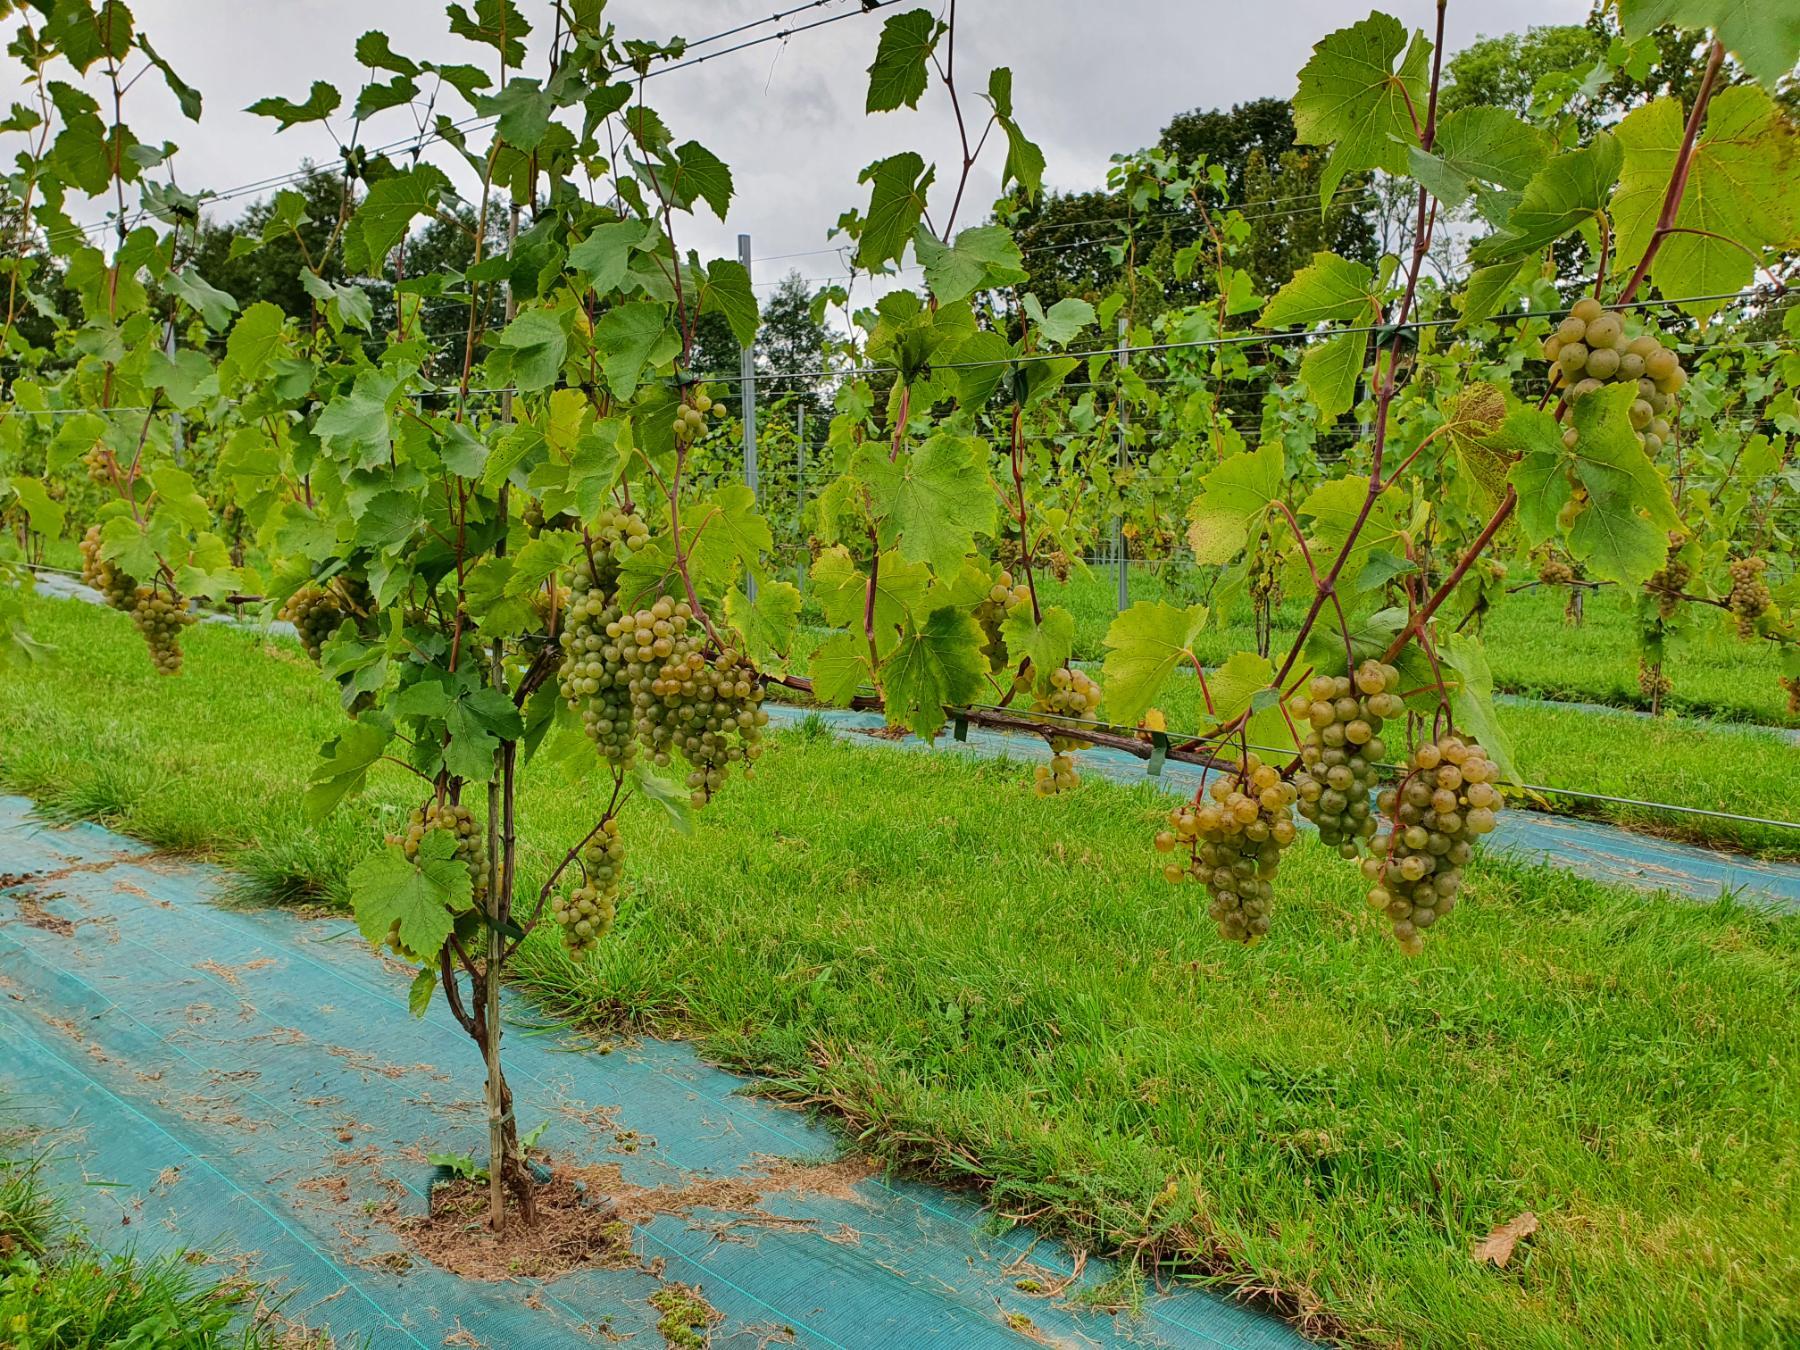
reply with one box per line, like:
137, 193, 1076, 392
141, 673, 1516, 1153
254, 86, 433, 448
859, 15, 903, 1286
763, 702, 1800, 913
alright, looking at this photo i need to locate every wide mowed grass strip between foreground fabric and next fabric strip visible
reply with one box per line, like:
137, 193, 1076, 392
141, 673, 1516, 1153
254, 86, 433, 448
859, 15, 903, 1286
0, 603, 1800, 1346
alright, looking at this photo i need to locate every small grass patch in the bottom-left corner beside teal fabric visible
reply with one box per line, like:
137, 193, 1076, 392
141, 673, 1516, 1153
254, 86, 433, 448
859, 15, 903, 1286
0, 1156, 329, 1350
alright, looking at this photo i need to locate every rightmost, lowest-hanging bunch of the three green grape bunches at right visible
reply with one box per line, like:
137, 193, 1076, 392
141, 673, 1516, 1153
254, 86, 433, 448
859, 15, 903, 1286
1363, 734, 1501, 956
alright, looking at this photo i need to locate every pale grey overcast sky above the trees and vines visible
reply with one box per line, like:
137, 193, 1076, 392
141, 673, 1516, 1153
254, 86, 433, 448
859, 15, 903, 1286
21, 0, 1589, 284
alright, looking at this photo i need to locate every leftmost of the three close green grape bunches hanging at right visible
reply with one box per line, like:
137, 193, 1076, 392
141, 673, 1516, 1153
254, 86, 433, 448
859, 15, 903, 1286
1156, 754, 1296, 945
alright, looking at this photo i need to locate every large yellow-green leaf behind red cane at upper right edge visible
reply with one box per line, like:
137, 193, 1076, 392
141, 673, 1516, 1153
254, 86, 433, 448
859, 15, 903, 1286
1613, 85, 1800, 317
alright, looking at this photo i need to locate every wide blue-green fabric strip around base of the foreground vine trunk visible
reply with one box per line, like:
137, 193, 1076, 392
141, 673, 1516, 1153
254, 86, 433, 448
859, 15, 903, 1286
0, 797, 1305, 1350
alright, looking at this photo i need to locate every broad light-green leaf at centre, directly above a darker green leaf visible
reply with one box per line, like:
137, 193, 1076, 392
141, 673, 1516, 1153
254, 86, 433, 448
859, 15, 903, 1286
851, 432, 997, 574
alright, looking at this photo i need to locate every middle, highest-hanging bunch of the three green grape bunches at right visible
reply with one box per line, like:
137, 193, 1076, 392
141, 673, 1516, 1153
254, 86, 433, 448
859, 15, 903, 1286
1289, 661, 1406, 859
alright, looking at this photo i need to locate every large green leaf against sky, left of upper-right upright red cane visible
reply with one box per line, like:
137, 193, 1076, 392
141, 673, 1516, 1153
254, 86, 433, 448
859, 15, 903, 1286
1294, 13, 1431, 211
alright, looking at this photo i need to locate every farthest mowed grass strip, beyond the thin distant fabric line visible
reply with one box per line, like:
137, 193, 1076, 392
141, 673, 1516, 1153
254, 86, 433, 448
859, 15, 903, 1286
928, 563, 1800, 727
